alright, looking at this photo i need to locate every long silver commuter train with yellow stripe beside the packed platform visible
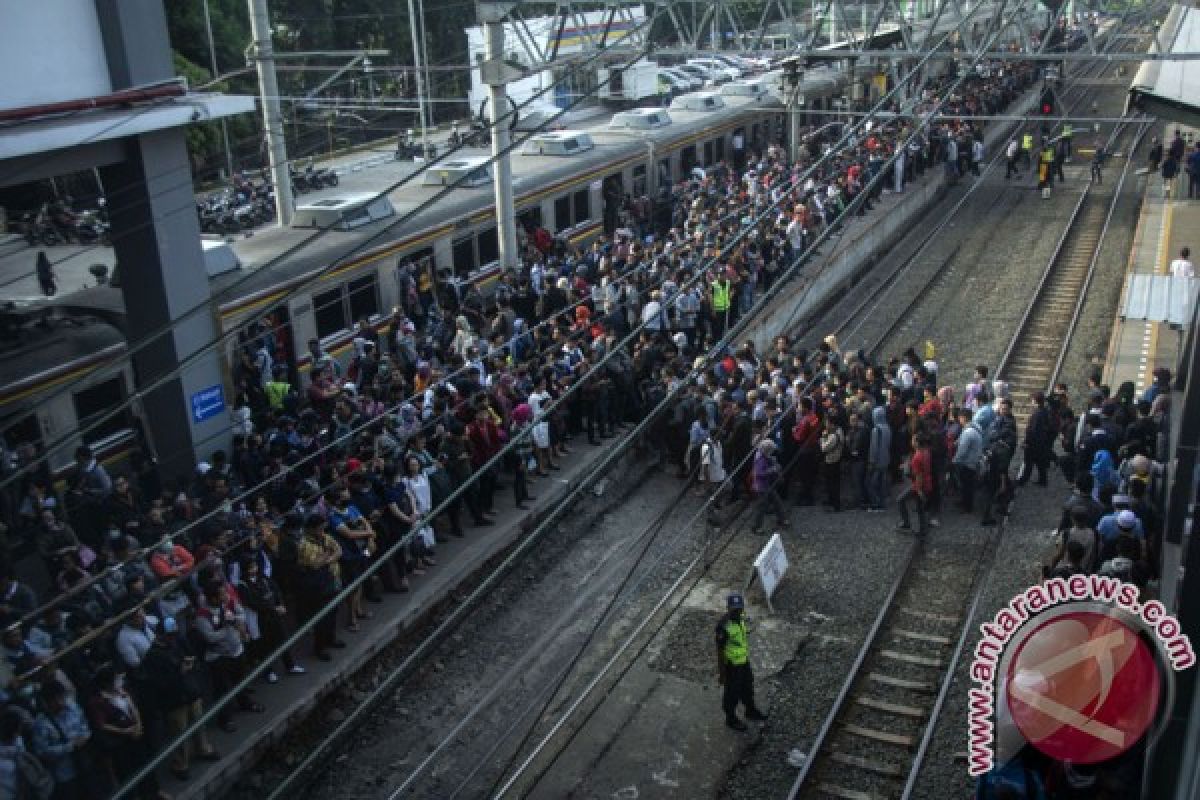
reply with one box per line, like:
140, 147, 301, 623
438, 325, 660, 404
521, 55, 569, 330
0, 0, 993, 474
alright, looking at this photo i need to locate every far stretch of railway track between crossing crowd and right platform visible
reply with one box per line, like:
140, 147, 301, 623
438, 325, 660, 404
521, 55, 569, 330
996, 116, 1146, 431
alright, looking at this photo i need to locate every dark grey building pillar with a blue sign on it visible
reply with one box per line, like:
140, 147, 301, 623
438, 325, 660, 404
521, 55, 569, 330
96, 0, 230, 476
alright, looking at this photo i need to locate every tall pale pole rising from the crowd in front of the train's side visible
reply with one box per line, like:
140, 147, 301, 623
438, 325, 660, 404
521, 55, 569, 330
478, 0, 522, 270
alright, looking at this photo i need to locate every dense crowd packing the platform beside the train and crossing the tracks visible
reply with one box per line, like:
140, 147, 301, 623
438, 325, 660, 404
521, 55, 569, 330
0, 57, 1104, 796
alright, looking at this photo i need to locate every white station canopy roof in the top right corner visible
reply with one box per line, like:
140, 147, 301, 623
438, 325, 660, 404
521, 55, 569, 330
1129, 5, 1200, 127
